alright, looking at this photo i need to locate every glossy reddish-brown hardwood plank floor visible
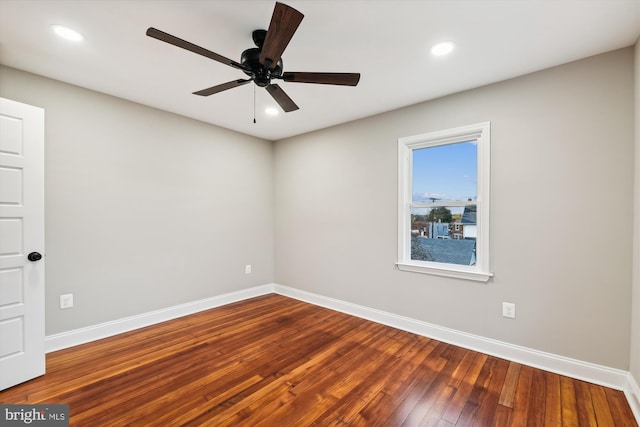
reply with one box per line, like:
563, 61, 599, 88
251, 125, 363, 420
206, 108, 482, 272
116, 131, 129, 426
0, 295, 637, 427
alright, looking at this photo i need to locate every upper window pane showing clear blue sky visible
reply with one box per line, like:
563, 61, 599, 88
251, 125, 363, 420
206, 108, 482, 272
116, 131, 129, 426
412, 141, 478, 202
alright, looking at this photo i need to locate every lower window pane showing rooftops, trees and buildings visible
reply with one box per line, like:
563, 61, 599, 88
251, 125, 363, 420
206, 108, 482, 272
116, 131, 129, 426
411, 205, 477, 265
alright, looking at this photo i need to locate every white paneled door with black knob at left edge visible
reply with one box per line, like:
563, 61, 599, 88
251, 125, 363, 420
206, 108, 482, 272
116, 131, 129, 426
0, 98, 45, 390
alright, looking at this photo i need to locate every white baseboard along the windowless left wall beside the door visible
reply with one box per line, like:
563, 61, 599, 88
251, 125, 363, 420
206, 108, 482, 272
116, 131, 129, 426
45, 285, 274, 353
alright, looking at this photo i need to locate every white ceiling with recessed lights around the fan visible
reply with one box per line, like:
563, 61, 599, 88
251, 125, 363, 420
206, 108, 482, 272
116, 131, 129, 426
0, 0, 640, 140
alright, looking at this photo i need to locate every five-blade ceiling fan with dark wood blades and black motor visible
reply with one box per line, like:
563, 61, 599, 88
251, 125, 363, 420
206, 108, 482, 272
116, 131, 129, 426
147, 2, 360, 112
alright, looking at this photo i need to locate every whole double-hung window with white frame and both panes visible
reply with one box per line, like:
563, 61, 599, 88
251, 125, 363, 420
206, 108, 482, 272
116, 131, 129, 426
397, 122, 493, 282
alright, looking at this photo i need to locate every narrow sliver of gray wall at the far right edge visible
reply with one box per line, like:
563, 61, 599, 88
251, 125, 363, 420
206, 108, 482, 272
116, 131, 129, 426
630, 39, 640, 384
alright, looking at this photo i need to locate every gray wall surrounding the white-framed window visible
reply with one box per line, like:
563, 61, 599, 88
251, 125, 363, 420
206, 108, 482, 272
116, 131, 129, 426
275, 48, 634, 370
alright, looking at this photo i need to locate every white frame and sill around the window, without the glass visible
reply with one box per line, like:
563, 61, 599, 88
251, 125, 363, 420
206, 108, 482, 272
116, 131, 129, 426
396, 122, 493, 282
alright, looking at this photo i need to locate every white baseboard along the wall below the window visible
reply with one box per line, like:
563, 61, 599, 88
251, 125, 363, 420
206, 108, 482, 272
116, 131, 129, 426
274, 285, 630, 390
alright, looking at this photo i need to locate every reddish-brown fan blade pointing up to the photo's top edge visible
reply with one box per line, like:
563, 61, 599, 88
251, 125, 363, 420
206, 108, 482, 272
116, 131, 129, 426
259, 2, 304, 68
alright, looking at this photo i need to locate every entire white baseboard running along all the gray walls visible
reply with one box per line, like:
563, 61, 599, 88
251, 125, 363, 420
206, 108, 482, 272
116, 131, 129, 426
45, 284, 640, 423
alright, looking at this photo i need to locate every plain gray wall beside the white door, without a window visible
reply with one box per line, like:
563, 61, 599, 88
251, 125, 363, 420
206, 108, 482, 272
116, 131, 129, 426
0, 67, 274, 335
